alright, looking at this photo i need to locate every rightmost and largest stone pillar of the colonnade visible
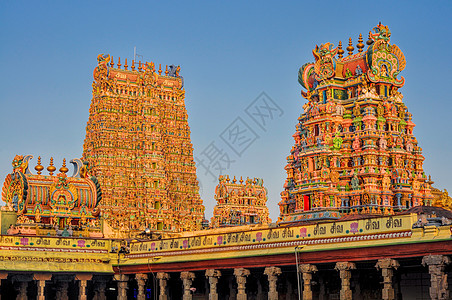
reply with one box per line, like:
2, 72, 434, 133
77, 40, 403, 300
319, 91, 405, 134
422, 255, 451, 300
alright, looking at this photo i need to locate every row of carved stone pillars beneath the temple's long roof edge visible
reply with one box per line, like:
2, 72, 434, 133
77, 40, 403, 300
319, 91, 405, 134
0, 255, 451, 300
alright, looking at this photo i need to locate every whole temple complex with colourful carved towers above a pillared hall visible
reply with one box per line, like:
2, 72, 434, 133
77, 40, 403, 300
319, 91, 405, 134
0, 24, 452, 300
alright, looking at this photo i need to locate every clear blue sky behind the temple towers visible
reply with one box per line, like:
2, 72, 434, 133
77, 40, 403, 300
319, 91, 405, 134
0, 1, 452, 220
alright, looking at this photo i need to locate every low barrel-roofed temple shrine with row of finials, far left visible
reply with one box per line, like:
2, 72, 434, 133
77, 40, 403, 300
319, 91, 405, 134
0, 155, 103, 237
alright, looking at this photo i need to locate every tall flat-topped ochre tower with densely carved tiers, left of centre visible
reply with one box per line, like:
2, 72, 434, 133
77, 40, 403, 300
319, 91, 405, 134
83, 54, 204, 234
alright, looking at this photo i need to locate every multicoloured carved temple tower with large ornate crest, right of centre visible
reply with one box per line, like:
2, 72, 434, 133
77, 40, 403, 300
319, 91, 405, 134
279, 24, 433, 222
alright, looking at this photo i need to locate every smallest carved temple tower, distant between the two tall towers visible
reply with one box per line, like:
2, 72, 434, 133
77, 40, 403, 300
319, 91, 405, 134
211, 175, 271, 228
